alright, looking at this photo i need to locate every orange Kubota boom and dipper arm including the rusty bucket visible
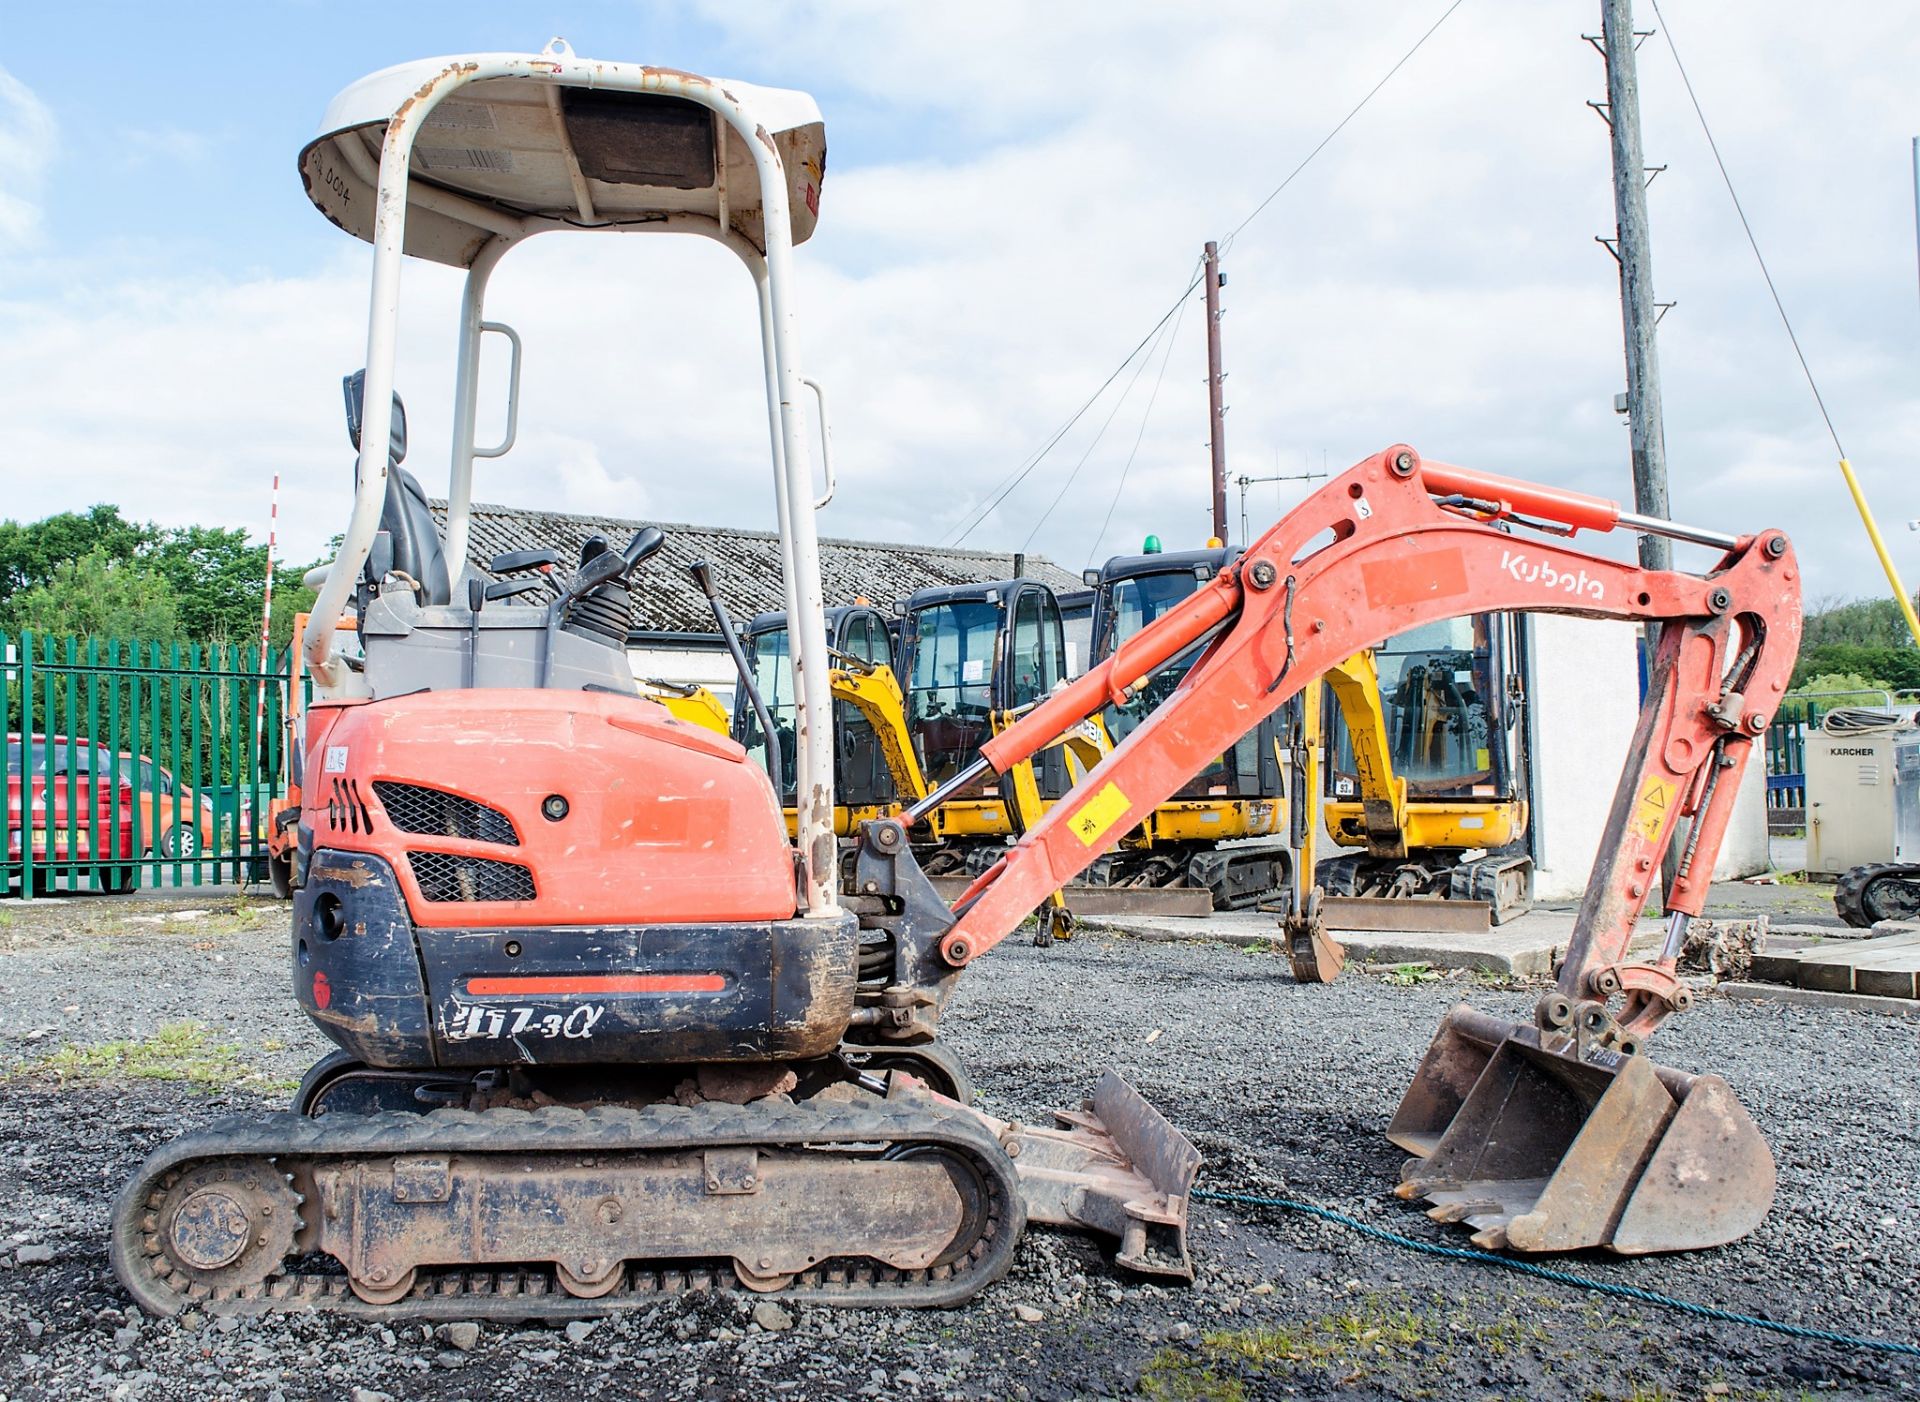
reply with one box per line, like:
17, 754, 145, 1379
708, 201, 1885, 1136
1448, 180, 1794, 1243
921, 446, 1801, 1252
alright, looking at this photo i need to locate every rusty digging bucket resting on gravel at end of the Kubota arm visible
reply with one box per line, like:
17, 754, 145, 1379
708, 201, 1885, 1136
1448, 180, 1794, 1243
1386, 1006, 1774, 1256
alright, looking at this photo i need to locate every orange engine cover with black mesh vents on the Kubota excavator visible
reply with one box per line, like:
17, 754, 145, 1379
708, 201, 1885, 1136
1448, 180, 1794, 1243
301, 689, 795, 930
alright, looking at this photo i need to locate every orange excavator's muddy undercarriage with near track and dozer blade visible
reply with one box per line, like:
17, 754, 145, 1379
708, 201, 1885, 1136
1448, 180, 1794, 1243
111, 1072, 1198, 1317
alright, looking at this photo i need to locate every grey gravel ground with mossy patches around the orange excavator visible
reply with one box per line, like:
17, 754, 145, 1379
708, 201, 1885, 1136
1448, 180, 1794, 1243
0, 897, 1920, 1402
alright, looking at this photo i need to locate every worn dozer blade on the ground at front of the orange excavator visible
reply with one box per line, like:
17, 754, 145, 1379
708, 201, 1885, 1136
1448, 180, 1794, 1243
975, 1072, 1200, 1281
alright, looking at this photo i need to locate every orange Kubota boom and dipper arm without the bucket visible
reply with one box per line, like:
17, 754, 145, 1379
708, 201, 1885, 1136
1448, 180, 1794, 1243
941, 447, 1799, 1035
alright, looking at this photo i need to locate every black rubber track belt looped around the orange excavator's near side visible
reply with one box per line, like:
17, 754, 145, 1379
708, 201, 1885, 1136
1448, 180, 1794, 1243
109, 1097, 1025, 1319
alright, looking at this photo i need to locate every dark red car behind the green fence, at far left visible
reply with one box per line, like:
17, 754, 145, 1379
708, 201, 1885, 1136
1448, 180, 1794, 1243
6, 734, 138, 891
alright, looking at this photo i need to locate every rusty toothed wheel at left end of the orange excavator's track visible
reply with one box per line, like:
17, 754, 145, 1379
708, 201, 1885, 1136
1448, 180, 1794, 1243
140, 1158, 300, 1298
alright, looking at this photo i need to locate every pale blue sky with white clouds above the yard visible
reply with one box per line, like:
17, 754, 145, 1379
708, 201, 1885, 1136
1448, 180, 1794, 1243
0, 0, 1920, 597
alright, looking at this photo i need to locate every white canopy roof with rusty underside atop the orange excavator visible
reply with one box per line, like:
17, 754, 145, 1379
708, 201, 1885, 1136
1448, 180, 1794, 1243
300, 46, 826, 267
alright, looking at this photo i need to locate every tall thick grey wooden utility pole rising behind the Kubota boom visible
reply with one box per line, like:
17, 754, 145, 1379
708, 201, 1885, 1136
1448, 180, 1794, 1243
1599, 0, 1672, 570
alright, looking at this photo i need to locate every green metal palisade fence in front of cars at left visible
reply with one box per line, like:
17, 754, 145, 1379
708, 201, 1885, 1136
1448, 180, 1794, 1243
0, 634, 292, 899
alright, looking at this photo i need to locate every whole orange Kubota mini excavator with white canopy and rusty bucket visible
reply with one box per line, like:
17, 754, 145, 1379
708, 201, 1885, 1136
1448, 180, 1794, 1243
111, 44, 1799, 1319
